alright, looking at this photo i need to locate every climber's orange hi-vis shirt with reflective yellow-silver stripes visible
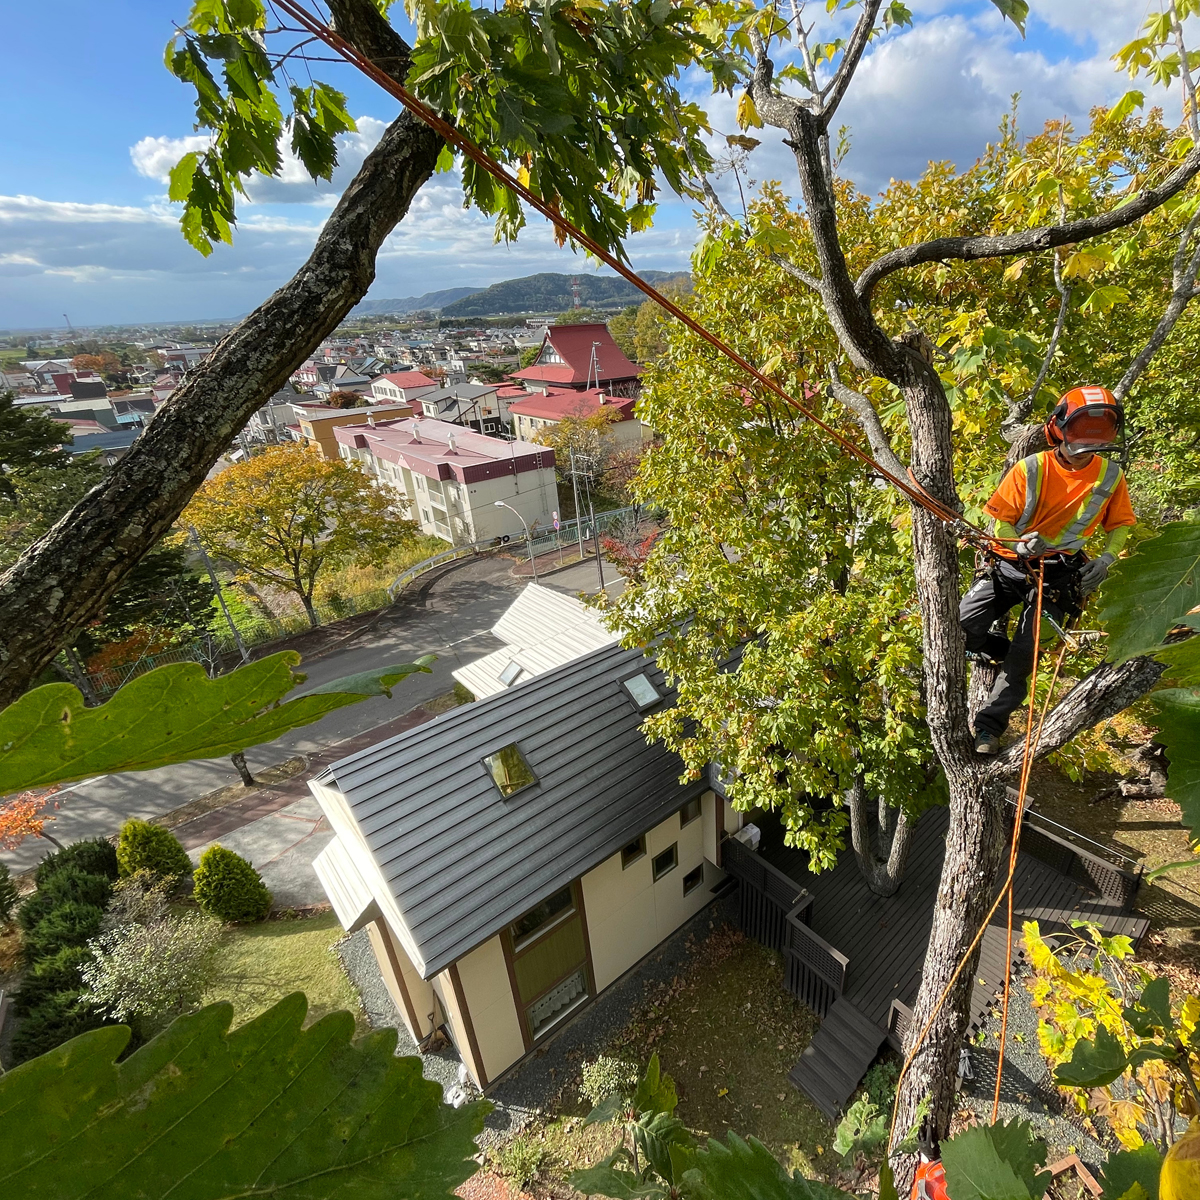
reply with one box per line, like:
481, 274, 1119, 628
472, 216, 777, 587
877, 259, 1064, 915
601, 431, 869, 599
984, 450, 1138, 558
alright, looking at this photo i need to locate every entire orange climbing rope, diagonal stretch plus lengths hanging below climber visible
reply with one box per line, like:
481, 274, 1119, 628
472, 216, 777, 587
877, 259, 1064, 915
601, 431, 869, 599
274, 0, 1080, 1145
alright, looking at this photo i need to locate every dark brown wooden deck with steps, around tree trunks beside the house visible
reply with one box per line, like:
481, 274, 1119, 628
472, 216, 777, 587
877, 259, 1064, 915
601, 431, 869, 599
755, 808, 1148, 1116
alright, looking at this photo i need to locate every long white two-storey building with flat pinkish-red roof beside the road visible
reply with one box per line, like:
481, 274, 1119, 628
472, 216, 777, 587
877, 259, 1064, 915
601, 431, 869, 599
334, 409, 558, 546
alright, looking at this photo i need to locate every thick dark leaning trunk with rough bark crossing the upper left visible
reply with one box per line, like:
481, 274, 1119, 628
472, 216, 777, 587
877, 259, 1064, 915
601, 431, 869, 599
0, 0, 443, 707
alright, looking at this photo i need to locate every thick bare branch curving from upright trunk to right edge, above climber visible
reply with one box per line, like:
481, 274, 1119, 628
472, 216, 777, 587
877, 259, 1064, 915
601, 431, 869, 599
854, 145, 1200, 304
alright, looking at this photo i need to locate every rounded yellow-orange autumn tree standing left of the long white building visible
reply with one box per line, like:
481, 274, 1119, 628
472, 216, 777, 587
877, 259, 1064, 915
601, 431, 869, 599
181, 443, 415, 626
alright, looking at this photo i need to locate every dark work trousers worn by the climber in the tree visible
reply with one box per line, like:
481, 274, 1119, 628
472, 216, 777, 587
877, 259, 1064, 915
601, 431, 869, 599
959, 554, 1087, 737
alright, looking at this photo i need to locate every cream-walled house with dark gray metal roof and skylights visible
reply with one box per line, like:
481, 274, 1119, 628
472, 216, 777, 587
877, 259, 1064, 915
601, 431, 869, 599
310, 646, 740, 1087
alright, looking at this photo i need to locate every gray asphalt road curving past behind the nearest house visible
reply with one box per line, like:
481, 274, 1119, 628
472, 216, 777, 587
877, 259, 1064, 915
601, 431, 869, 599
7, 557, 617, 874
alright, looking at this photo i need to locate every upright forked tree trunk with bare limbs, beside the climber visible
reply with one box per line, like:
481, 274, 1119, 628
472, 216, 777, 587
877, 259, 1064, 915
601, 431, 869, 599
749, 9, 1200, 1171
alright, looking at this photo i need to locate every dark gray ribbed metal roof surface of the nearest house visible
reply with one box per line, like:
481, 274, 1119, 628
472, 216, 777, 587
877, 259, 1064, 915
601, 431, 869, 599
322, 646, 707, 978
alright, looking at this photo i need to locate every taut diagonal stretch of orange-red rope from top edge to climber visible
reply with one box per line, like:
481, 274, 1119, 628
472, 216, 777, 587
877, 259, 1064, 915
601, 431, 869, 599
272, 0, 998, 551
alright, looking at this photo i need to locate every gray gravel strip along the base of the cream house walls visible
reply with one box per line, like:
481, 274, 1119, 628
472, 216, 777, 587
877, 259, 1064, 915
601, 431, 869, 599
337, 896, 737, 1147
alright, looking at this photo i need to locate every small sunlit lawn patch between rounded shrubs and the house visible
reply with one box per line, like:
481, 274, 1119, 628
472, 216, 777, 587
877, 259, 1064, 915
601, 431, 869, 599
204, 912, 367, 1033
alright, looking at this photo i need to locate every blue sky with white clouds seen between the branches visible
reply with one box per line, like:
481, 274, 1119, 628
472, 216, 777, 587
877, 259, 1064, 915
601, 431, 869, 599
0, 0, 1161, 328
